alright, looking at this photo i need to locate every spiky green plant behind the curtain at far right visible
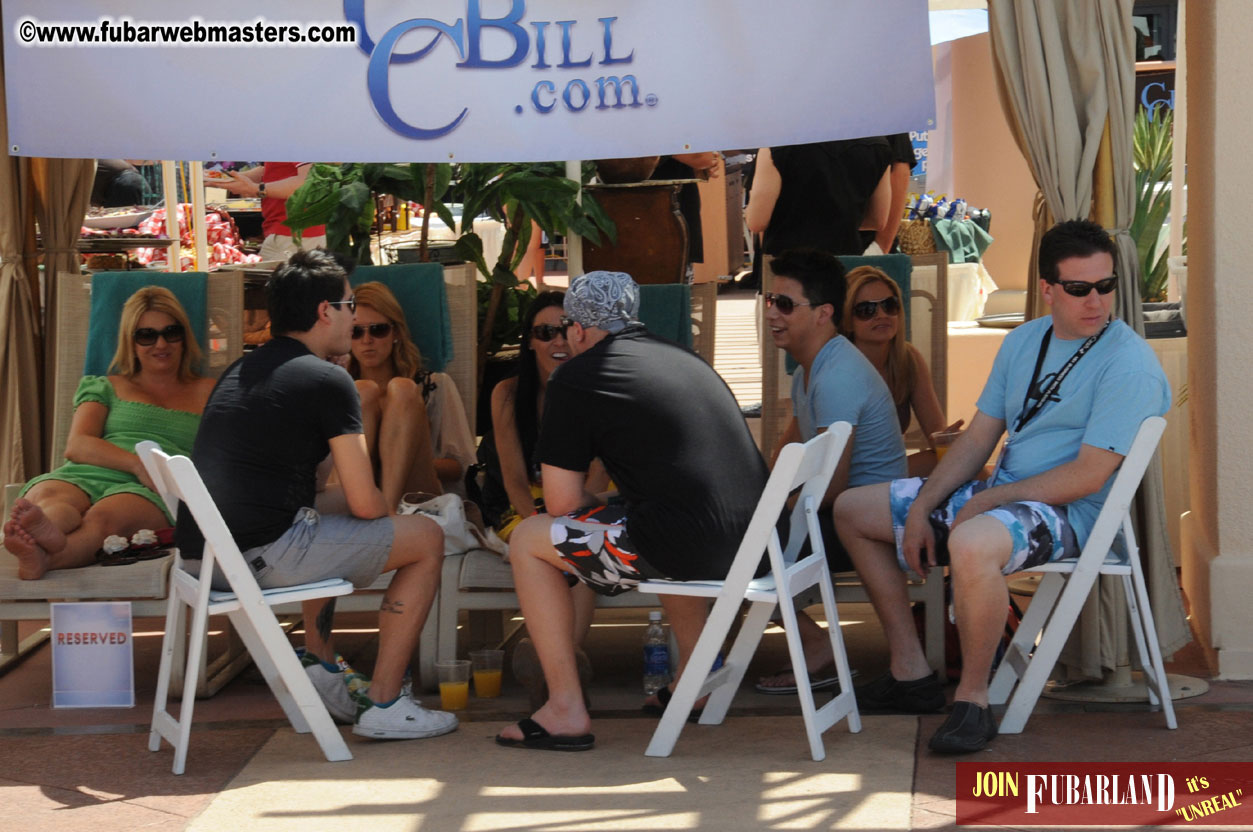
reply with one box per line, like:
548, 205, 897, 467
1130, 107, 1187, 301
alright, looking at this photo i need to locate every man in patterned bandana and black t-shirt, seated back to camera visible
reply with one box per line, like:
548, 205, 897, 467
496, 272, 767, 751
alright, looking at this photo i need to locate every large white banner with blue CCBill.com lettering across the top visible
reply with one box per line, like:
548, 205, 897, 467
3, 0, 935, 162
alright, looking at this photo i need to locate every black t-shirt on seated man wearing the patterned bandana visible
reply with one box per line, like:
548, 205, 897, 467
536, 326, 767, 580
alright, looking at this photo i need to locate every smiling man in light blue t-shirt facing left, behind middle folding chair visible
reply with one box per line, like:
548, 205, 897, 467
757, 249, 907, 693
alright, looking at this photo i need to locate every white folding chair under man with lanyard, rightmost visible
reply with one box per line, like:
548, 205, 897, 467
987, 416, 1175, 734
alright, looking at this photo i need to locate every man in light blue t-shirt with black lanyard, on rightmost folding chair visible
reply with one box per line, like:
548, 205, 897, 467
836, 221, 1170, 753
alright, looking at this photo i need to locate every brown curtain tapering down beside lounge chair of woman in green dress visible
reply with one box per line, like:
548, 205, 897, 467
30, 153, 95, 467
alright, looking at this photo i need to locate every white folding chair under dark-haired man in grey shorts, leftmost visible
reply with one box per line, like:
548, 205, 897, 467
135, 441, 352, 774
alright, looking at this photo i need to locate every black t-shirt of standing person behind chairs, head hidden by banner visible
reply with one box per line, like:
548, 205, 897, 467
762, 137, 891, 254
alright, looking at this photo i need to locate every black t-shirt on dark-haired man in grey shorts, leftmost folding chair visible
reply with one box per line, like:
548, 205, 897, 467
175, 337, 361, 558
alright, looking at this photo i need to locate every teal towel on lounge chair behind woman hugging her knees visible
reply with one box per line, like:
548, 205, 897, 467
350, 263, 452, 372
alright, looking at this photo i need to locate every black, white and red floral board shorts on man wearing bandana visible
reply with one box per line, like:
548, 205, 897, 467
550, 505, 664, 595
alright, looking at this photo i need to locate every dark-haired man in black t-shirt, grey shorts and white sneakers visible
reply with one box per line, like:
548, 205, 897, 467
175, 249, 457, 739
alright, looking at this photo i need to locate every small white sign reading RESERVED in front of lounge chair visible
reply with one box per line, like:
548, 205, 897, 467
51, 601, 135, 708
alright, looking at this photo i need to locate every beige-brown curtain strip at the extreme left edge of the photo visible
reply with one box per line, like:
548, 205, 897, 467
0, 35, 44, 482
